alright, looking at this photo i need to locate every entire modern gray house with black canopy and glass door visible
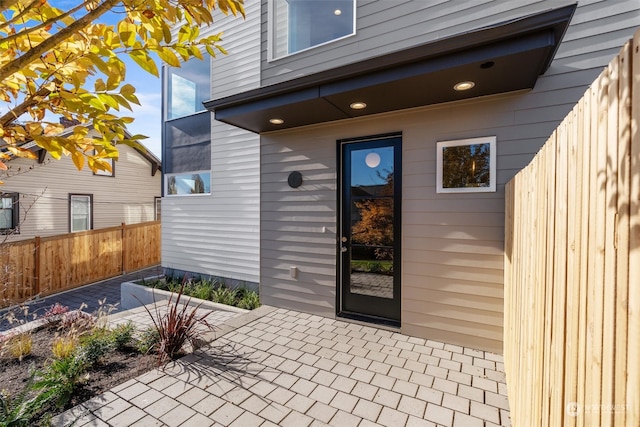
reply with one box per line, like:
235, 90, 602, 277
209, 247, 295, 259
163, 0, 640, 353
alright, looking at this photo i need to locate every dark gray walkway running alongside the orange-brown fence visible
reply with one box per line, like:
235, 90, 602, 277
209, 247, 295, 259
0, 265, 162, 331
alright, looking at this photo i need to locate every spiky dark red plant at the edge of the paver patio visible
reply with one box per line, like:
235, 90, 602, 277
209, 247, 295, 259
144, 277, 212, 365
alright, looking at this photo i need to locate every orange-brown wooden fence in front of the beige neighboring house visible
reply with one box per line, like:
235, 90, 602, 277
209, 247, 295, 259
0, 221, 160, 306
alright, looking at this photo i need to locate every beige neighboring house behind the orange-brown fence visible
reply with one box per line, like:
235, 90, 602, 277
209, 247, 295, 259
0, 128, 162, 241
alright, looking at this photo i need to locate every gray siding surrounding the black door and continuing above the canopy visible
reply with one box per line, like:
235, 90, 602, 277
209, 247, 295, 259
261, 1, 640, 352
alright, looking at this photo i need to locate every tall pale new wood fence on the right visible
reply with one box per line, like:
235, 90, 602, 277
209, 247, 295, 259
504, 31, 640, 426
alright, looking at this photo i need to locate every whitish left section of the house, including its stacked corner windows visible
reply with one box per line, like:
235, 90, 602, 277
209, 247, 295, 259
162, 2, 260, 285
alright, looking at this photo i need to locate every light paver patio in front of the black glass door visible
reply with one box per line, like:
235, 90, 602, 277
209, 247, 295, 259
53, 307, 510, 427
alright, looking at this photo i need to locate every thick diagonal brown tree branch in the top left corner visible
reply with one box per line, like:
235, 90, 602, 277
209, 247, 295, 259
0, 0, 121, 80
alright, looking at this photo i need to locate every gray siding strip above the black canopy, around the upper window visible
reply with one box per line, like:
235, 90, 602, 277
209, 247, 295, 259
261, 0, 572, 86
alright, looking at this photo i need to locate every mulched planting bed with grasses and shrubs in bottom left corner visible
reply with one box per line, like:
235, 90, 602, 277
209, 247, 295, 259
0, 304, 160, 426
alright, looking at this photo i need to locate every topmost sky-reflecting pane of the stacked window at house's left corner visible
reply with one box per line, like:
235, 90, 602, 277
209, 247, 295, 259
166, 55, 211, 120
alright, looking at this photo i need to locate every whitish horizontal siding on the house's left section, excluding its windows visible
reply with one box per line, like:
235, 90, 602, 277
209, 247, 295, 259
162, 2, 260, 283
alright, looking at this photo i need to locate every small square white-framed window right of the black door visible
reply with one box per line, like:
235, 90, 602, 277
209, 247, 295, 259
436, 136, 496, 193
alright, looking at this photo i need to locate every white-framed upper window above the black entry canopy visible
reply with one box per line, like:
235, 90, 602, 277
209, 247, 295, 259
270, 0, 356, 59
